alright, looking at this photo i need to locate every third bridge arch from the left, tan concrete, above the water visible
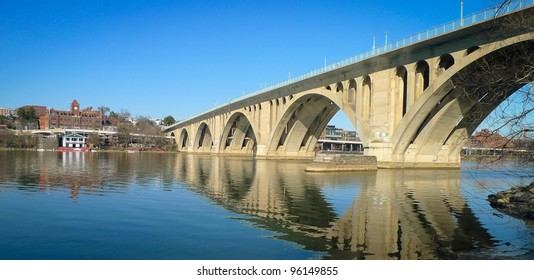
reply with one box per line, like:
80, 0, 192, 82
219, 112, 257, 154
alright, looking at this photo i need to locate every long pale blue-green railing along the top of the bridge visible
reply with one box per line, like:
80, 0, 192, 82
176, 0, 534, 128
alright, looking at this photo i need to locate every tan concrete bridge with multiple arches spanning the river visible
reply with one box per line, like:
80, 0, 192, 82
165, 1, 534, 167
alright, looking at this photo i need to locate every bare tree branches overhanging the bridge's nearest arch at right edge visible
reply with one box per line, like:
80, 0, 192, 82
454, 0, 534, 166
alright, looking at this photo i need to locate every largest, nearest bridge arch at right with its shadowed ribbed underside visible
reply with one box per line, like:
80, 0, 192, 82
392, 34, 534, 162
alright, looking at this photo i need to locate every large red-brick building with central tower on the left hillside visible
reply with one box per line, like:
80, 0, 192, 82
39, 100, 103, 130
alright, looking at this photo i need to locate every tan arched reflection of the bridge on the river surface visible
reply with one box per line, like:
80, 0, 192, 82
174, 155, 495, 259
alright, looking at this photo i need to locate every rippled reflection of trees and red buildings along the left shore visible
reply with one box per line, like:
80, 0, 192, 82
0, 151, 180, 199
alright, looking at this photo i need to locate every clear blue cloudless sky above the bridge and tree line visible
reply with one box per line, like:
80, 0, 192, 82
0, 0, 499, 128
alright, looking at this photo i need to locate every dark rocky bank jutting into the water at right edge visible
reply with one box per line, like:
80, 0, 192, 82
488, 182, 534, 220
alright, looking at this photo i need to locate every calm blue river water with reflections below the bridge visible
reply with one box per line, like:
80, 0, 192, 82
0, 151, 534, 260
